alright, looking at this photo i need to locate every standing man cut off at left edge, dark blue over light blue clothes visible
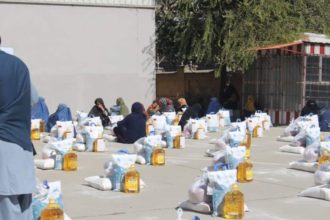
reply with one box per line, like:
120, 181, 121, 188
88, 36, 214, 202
0, 37, 38, 220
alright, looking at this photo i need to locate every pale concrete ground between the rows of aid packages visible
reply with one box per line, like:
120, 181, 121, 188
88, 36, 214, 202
36, 127, 330, 220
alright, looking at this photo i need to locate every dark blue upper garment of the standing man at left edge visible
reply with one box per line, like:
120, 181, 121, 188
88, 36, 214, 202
0, 51, 33, 152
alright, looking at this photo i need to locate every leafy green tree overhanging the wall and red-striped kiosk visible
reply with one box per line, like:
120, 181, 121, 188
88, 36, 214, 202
156, 0, 330, 76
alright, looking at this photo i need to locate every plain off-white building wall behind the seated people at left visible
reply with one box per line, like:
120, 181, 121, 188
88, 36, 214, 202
0, 1, 155, 112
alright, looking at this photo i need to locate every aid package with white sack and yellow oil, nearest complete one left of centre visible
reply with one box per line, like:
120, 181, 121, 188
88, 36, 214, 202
85, 153, 145, 193
